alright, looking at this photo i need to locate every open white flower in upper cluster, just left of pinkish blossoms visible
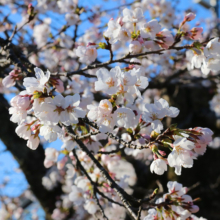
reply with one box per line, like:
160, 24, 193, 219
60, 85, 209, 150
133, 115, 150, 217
140, 19, 161, 40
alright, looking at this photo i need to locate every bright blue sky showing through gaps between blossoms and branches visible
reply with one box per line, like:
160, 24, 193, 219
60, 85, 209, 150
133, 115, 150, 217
0, 0, 217, 219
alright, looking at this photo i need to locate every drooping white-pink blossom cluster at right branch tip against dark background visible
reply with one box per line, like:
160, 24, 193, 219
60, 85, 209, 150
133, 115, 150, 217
150, 127, 213, 175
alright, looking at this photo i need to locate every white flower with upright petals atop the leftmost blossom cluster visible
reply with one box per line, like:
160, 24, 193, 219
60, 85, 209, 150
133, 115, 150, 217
23, 67, 50, 94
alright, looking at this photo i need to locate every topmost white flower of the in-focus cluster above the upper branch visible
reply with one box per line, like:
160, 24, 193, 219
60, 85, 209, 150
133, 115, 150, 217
122, 8, 144, 23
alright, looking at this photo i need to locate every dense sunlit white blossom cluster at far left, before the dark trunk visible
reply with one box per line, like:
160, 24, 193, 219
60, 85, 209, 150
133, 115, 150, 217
9, 68, 86, 149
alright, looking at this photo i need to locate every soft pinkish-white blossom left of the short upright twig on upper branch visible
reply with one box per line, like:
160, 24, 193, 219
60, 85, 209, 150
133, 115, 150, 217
76, 45, 97, 63
